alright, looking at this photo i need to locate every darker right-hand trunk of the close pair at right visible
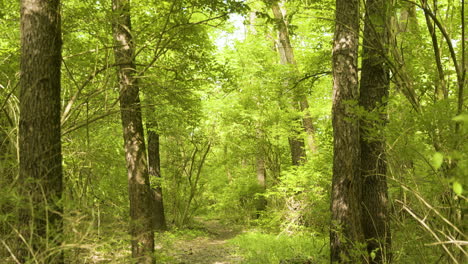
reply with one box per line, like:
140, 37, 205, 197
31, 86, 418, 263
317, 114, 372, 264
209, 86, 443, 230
359, 0, 391, 263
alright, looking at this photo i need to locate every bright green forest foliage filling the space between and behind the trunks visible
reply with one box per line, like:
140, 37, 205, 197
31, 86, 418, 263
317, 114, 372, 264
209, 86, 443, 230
0, 0, 468, 263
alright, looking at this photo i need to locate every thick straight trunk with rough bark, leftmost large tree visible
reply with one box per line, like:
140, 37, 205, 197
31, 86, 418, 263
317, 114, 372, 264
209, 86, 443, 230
17, 0, 63, 263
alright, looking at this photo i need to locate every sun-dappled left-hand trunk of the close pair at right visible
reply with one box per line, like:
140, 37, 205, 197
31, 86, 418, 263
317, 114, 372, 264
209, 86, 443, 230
330, 0, 364, 263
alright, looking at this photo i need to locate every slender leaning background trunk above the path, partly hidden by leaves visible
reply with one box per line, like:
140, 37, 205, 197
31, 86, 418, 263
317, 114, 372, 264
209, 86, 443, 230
271, 1, 316, 165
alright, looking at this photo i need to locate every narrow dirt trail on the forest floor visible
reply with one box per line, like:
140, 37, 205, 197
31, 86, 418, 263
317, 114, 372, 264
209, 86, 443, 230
169, 219, 242, 264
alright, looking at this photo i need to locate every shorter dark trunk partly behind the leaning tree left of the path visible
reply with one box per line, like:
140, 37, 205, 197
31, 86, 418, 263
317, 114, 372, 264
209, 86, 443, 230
147, 123, 167, 231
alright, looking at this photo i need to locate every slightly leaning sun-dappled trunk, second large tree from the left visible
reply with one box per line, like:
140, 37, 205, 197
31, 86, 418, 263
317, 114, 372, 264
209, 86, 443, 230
112, 0, 154, 263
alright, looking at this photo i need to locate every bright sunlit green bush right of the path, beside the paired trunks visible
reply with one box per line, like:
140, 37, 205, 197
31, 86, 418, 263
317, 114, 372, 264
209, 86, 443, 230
265, 153, 331, 233
